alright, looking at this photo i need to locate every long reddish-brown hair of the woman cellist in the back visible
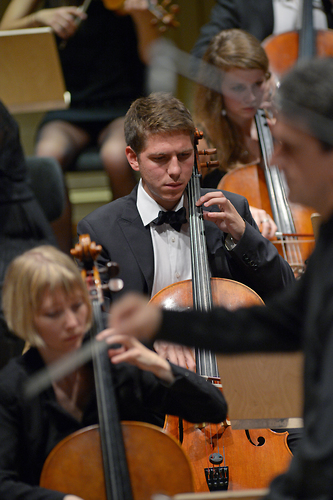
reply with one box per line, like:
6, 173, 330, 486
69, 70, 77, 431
193, 29, 270, 171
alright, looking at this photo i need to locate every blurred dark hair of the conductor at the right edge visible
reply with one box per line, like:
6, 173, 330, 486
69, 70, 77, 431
277, 58, 333, 150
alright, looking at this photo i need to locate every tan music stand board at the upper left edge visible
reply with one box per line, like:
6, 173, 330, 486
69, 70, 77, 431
0, 27, 70, 113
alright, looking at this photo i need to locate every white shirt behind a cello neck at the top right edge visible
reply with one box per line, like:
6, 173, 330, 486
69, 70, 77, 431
273, 0, 327, 35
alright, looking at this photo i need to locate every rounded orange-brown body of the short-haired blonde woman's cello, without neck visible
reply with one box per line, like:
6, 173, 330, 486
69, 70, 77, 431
40, 422, 193, 500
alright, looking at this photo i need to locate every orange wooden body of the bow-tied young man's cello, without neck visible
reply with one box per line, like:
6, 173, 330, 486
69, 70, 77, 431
151, 278, 292, 492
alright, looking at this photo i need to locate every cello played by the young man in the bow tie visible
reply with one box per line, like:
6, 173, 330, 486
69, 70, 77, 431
151, 131, 291, 492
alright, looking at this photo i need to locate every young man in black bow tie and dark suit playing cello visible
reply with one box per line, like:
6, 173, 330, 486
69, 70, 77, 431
78, 93, 294, 363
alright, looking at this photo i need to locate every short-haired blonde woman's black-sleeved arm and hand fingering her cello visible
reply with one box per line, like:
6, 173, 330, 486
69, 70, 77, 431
94, 329, 227, 423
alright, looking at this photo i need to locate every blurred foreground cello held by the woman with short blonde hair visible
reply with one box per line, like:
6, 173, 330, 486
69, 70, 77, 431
40, 235, 193, 500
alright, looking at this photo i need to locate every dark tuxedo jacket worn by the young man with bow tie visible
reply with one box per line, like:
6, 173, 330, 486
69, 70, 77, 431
78, 187, 294, 300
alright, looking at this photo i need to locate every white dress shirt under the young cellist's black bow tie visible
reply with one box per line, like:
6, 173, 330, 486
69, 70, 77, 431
137, 179, 192, 297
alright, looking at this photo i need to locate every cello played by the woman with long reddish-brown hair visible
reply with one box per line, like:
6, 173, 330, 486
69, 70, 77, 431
218, 109, 315, 277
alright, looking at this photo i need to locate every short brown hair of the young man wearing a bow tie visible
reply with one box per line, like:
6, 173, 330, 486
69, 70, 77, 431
124, 92, 195, 155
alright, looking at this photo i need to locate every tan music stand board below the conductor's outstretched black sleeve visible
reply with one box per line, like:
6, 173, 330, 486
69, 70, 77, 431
217, 353, 303, 429
